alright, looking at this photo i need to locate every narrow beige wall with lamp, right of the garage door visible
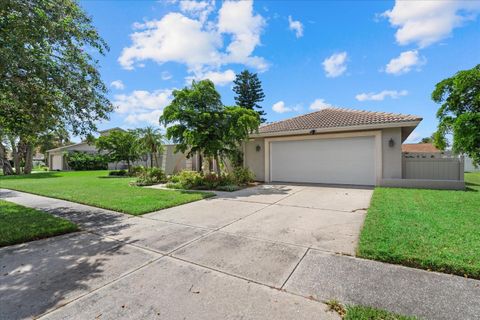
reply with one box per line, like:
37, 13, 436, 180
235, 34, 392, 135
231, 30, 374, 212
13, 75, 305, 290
382, 128, 402, 179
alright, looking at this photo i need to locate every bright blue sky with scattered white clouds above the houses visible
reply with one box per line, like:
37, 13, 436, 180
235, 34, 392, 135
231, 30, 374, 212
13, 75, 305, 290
80, 1, 480, 142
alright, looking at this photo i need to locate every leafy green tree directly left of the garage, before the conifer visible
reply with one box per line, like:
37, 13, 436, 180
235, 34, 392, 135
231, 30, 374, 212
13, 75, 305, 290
160, 80, 259, 172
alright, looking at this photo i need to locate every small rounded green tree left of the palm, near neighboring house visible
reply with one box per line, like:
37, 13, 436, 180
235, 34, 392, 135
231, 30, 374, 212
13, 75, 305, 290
95, 130, 142, 172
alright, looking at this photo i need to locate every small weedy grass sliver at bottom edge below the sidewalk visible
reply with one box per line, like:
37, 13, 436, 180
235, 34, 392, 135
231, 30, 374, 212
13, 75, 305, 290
325, 300, 417, 320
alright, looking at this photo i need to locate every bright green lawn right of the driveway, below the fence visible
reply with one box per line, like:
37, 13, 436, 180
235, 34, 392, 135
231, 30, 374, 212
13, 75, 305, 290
357, 172, 480, 279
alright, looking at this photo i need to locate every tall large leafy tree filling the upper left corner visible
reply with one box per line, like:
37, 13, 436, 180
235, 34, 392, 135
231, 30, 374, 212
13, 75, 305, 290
0, 0, 113, 173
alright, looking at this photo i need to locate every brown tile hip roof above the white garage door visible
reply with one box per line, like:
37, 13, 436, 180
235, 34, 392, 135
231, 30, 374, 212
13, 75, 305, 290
258, 108, 422, 134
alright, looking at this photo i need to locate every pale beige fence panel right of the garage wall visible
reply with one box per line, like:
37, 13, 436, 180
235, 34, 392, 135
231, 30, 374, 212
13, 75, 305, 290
402, 154, 464, 181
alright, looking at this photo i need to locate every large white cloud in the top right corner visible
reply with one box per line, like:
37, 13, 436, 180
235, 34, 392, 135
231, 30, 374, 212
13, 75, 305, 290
383, 0, 480, 48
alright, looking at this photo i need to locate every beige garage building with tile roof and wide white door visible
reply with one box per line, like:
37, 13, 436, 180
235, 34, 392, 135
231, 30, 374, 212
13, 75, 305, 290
244, 108, 464, 188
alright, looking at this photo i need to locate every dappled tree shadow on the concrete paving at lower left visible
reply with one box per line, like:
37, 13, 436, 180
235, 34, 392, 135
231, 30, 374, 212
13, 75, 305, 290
0, 194, 147, 319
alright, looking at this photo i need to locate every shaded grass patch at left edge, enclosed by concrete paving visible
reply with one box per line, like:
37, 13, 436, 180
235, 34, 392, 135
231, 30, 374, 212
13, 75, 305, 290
0, 200, 78, 247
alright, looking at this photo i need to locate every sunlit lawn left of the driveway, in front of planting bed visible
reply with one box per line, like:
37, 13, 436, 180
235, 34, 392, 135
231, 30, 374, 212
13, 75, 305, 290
0, 171, 213, 215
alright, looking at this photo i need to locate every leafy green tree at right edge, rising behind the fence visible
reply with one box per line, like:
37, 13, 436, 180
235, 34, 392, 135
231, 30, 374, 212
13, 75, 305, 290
432, 65, 480, 164
